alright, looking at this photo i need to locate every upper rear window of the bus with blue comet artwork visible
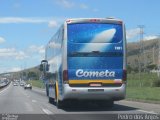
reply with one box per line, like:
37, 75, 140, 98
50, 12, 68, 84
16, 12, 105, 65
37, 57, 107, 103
67, 23, 123, 43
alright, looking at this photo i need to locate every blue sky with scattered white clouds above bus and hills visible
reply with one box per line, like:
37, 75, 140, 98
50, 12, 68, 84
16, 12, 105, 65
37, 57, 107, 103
0, 0, 160, 73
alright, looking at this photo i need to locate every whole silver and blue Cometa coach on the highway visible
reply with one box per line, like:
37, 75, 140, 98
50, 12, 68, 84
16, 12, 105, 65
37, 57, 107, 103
40, 18, 127, 108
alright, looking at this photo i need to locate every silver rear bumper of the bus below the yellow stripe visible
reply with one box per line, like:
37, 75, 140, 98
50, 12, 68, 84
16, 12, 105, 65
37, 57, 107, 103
62, 84, 126, 101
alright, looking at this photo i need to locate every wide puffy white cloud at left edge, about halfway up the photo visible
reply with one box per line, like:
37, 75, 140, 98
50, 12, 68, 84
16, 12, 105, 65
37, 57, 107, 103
0, 48, 29, 60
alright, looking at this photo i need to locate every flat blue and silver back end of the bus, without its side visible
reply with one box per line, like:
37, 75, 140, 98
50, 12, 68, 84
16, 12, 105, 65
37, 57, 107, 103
63, 19, 126, 101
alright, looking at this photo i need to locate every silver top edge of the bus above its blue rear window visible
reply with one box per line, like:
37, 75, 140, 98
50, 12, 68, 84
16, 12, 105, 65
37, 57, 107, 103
65, 17, 123, 24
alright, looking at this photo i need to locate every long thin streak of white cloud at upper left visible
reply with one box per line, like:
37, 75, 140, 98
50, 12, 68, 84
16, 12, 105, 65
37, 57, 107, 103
0, 17, 49, 24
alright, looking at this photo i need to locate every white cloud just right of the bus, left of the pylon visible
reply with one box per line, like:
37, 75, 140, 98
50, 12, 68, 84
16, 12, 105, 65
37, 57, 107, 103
126, 28, 140, 40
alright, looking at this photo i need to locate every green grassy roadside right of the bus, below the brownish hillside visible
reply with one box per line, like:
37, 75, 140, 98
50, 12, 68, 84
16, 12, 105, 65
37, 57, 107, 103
126, 73, 160, 103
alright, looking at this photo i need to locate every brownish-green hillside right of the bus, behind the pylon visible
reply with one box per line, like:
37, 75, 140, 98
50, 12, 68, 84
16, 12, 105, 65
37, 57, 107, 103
127, 39, 159, 71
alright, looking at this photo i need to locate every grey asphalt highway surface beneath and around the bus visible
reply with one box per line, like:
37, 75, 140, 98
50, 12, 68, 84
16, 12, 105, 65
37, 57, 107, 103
0, 84, 160, 120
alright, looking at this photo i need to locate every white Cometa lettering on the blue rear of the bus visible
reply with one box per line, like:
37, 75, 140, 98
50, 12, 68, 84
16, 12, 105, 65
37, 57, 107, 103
76, 69, 115, 77
